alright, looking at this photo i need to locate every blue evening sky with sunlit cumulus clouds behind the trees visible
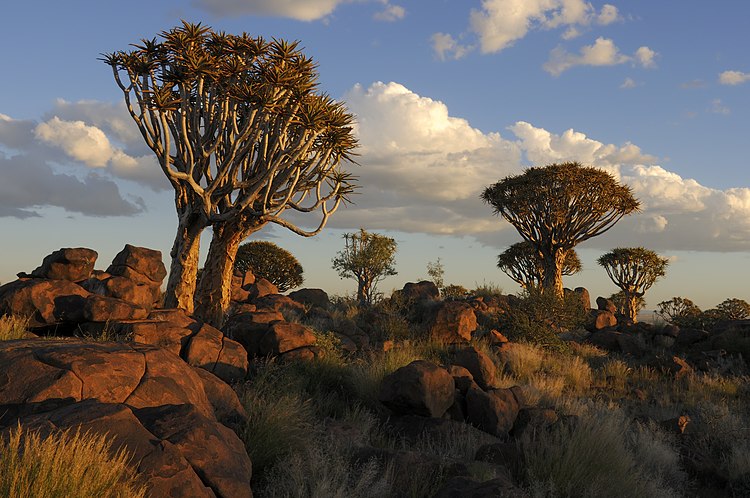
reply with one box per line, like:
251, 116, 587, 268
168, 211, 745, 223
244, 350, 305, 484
0, 0, 750, 309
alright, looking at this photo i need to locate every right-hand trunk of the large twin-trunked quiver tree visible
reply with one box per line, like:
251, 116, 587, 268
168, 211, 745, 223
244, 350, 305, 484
195, 221, 261, 328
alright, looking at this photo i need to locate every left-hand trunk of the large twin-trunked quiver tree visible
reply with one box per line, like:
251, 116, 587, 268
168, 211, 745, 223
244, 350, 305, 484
164, 206, 206, 313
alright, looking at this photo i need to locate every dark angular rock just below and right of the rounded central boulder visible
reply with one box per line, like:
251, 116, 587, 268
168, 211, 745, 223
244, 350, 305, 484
466, 389, 519, 437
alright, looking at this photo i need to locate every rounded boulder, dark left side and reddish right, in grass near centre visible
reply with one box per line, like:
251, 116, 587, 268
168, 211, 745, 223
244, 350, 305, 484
378, 360, 454, 418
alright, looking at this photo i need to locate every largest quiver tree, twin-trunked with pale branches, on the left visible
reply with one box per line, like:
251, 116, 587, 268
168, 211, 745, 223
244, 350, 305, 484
104, 22, 357, 325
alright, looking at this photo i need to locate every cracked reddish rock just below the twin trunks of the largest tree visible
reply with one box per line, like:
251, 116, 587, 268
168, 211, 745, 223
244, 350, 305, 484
181, 323, 248, 383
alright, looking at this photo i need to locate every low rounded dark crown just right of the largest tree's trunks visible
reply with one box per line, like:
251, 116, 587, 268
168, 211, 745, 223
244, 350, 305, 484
234, 240, 305, 292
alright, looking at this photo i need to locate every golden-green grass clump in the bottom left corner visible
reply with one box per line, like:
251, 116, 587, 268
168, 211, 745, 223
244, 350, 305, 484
0, 425, 145, 498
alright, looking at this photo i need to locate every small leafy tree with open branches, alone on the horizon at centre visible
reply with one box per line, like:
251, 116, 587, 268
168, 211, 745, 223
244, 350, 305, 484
332, 228, 397, 305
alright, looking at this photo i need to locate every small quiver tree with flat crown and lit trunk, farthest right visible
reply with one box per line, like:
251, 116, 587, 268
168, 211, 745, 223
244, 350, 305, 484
597, 247, 669, 323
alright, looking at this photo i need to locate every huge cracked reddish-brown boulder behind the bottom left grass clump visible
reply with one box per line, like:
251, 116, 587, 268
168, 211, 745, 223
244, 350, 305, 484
0, 339, 252, 497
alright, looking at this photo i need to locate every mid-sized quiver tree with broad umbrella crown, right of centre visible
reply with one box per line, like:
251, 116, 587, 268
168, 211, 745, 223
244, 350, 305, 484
481, 162, 639, 297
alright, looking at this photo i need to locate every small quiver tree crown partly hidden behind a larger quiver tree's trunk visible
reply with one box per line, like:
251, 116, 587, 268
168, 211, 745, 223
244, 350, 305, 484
497, 241, 582, 290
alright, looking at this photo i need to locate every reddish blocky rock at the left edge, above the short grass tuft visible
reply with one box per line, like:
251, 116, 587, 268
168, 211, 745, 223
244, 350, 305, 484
0, 278, 90, 327
